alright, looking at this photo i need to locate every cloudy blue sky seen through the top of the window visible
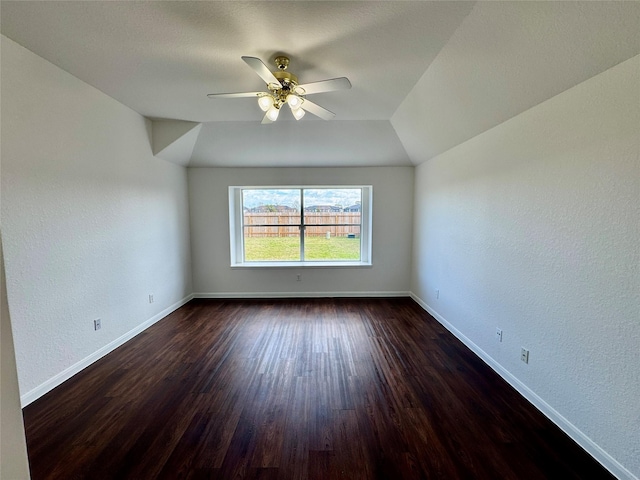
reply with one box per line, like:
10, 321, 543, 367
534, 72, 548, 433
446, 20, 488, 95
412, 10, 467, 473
242, 188, 362, 208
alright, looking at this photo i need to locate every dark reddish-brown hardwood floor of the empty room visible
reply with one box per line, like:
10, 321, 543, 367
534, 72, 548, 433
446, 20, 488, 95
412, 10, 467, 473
24, 299, 613, 480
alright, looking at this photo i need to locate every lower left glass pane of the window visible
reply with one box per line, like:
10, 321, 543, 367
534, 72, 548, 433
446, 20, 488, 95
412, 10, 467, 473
244, 225, 300, 262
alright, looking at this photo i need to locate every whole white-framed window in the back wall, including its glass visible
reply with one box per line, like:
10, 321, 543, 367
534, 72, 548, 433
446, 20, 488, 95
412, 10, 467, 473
229, 186, 372, 267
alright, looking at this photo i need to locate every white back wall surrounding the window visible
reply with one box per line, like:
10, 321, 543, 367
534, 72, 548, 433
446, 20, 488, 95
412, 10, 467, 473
188, 167, 414, 296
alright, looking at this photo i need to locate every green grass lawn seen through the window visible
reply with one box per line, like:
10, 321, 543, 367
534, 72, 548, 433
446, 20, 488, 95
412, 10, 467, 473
244, 237, 360, 262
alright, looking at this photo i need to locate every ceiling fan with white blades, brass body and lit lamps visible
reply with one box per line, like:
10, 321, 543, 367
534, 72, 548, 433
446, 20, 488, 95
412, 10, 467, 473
207, 56, 351, 124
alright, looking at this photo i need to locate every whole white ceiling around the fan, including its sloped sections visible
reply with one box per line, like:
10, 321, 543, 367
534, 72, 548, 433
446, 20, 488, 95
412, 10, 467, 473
0, 1, 640, 166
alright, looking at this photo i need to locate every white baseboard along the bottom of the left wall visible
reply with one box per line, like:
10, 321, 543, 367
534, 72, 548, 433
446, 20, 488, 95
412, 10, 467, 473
20, 294, 193, 408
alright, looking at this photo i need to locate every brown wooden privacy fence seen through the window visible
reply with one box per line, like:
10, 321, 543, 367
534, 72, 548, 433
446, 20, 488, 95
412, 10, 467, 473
244, 212, 360, 237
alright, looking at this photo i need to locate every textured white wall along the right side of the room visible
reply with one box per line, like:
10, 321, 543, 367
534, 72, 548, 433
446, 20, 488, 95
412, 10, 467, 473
411, 56, 640, 478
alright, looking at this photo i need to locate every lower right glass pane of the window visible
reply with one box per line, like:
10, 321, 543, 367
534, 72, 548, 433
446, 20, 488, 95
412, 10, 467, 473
304, 225, 360, 261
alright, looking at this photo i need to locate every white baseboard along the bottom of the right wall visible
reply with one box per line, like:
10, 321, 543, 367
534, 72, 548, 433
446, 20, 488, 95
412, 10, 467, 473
409, 292, 638, 480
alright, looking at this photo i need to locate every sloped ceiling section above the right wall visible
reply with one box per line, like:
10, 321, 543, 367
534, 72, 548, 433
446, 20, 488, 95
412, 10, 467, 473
391, 2, 640, 165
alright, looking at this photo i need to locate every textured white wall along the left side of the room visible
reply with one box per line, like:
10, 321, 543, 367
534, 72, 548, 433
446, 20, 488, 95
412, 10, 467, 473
1, 37, 192, 403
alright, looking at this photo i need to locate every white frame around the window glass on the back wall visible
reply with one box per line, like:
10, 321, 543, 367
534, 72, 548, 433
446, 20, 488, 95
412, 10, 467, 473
229, 185, 373, 268
